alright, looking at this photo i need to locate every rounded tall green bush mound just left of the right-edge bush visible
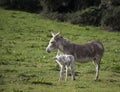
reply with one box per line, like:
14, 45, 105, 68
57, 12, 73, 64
71, 7, 101, 26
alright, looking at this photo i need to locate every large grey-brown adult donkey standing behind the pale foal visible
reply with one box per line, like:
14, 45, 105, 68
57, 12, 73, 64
46, 33, 104, 80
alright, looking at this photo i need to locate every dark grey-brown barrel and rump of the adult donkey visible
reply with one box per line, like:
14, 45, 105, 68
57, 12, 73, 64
70, 41, 104, 62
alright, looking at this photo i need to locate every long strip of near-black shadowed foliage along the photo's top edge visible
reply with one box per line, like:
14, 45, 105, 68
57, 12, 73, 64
0, 0, 101, 13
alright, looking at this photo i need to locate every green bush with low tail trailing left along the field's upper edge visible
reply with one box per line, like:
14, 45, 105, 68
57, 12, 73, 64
43, 7, 102, 26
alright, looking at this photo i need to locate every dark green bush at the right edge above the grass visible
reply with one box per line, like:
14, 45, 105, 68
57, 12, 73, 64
101, 6, 120, 31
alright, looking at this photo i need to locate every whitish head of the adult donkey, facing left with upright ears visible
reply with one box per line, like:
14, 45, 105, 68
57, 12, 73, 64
46, 33, 62, 53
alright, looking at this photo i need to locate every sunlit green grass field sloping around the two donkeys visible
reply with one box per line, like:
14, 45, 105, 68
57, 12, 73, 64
0, 9, 120, 92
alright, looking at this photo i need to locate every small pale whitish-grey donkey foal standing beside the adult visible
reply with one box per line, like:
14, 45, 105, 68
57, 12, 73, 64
54, 50, 75, 80
